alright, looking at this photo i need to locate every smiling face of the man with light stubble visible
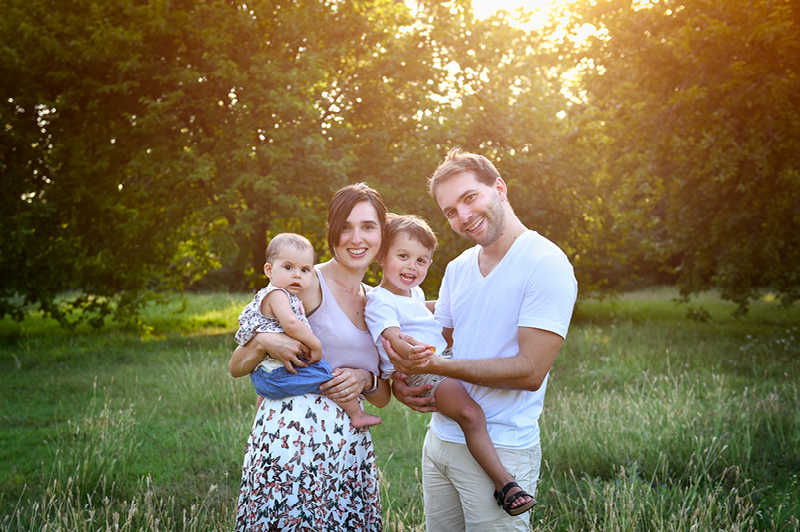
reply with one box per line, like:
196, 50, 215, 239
434, 172, 506, 247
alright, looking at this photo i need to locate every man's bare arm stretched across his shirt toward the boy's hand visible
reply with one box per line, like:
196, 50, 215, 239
384, 327, 564, 392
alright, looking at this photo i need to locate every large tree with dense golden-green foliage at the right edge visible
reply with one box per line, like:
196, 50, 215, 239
562, 0, 800, 312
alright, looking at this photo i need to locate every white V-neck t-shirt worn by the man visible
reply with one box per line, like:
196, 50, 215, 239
430, 231, 578, 449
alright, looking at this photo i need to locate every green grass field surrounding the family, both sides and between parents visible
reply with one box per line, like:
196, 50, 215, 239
0, 289, 800, 531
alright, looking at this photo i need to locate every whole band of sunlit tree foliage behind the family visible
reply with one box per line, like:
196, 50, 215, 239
0, 0, 800, 325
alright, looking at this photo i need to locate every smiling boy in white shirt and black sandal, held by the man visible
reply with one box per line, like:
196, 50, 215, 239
365, 215, 536, 515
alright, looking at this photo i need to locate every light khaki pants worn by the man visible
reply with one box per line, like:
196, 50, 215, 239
422, 429, 542, 532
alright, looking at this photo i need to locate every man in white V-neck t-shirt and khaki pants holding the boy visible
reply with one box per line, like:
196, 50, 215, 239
384, 149, 577, 532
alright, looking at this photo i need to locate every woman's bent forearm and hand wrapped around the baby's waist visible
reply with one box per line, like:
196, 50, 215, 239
228, 333, 308, 377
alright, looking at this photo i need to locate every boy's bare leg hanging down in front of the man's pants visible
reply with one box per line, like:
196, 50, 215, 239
435, 379, 532, 508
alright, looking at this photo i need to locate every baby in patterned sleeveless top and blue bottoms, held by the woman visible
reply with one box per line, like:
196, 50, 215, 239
236, 233, 382, 428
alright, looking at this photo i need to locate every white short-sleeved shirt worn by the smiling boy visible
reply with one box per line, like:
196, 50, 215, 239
364, 286, 447, 379
